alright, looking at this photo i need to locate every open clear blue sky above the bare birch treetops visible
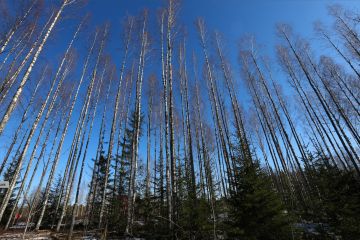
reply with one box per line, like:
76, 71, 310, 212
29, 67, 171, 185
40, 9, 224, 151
83, 0, 360, 56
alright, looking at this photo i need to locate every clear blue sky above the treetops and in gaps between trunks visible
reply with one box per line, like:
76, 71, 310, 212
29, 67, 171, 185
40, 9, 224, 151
0, 0, 360, 202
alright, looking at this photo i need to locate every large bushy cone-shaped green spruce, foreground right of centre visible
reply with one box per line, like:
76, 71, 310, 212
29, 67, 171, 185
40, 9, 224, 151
228, 134, 290, 240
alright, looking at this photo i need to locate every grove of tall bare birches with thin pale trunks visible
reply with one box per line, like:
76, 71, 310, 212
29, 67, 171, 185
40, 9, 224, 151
0, 0, 360, 239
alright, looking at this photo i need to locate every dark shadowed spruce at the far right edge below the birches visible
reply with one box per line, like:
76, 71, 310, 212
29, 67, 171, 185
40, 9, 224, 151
301, 153, 360, 240
